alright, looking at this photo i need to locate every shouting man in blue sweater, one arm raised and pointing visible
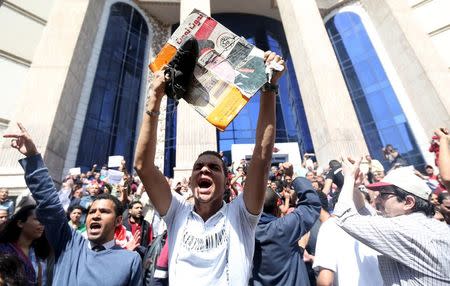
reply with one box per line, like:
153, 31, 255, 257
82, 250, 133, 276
3, 123, 142, 286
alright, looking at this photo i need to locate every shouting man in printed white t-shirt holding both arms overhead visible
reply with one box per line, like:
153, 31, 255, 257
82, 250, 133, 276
135, 44, 284, 286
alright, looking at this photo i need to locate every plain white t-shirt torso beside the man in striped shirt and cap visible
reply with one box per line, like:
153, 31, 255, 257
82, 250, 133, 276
313, 218, 383, 286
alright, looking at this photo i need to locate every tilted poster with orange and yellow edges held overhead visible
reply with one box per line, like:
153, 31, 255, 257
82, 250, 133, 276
149, 10, 267, 131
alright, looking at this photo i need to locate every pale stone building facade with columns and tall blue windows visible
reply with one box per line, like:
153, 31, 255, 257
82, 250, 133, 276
0, 0, 450, 191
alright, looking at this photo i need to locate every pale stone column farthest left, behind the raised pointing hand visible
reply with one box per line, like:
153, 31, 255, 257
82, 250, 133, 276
0, 0, 105, 189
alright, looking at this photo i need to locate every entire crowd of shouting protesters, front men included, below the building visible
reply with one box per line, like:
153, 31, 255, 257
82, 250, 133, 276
0, 48, 450, 285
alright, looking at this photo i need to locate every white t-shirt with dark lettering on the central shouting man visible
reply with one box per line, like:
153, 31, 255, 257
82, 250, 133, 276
163, 192, 259, 286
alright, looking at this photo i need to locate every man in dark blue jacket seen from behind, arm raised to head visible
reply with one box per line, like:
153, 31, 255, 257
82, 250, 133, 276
249, 165, 321, 285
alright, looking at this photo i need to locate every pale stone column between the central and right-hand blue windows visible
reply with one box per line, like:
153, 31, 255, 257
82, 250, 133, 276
278, 0, 368, 165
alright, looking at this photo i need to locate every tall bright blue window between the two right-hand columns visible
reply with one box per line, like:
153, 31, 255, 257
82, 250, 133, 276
325, 12, 425, 168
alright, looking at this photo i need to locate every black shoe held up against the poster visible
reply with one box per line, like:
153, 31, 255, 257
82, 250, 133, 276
164, 37, 198, 100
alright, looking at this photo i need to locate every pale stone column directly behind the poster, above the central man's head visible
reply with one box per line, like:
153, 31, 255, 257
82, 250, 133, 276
174, 0, 217, 182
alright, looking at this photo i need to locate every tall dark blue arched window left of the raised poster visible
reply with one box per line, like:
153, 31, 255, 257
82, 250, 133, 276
76, 3, 148, 170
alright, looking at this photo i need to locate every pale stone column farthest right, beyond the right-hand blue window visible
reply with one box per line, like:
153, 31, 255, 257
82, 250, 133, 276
361, 0, 450, 136
